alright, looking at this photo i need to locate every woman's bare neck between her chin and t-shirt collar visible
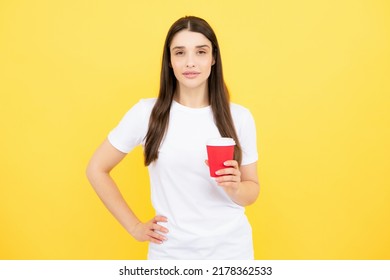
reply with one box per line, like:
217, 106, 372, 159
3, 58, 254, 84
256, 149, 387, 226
174, 83, 210, 108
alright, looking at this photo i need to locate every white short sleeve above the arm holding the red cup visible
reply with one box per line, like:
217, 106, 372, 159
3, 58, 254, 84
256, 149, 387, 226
235, 106, 258, 165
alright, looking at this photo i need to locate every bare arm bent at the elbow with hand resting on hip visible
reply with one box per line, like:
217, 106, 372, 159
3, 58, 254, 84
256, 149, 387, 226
87, 140, 168, 244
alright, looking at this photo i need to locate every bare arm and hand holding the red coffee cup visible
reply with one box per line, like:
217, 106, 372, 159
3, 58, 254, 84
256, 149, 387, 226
216, 160, 260, 206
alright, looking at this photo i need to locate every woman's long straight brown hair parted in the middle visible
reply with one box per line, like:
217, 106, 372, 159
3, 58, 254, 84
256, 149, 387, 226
144, 16, 242, 166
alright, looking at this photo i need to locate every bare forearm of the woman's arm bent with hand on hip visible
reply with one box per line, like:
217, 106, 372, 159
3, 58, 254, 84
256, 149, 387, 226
87, 171, 140, 235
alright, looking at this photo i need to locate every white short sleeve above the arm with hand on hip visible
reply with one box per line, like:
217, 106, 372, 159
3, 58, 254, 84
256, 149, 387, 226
107, 99, 155, 153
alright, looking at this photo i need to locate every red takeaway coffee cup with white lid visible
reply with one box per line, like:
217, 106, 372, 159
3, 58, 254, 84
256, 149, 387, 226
206, 137, 236, 177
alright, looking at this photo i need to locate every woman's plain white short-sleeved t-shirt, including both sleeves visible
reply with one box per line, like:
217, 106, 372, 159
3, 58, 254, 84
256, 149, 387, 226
108, 98, 258, 260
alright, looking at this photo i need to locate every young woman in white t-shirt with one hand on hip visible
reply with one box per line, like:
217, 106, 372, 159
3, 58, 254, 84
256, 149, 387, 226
87, 16, 259, 259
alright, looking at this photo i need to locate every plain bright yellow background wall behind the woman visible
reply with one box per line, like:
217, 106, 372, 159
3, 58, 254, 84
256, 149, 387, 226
0, 0, 390, 259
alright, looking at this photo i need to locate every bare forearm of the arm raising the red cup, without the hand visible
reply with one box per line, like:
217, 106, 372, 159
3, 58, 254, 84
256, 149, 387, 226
228, 181, 260, 206
